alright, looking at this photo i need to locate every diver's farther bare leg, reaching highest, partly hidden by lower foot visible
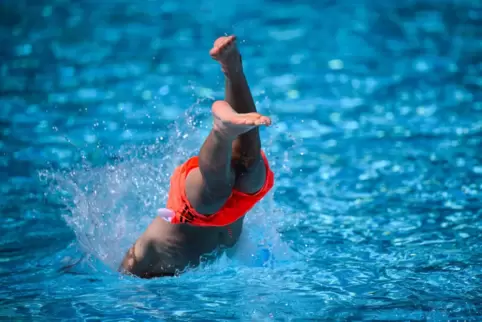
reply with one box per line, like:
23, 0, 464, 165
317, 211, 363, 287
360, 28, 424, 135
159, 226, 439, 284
210, 36, 266, 193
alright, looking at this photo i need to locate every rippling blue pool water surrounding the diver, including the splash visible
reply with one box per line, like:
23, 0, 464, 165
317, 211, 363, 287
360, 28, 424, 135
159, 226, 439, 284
0, 0, 482, 321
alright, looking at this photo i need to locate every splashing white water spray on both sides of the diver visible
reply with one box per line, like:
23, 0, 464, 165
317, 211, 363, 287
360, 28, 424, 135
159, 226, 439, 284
47, 100, 289, 269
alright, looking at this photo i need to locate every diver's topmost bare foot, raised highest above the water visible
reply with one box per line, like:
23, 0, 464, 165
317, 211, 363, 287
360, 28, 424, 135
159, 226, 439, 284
209, 36, 242, 73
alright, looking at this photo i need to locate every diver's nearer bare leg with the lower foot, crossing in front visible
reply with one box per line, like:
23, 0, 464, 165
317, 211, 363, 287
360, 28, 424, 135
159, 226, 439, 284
186, 101, 271, 215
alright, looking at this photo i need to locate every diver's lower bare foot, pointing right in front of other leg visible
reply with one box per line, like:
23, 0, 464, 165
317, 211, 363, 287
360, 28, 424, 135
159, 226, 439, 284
212, 101, 271, 138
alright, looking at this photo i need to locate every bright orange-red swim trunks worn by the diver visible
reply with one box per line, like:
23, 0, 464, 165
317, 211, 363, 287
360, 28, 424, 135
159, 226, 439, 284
167, 152, 274, 226
